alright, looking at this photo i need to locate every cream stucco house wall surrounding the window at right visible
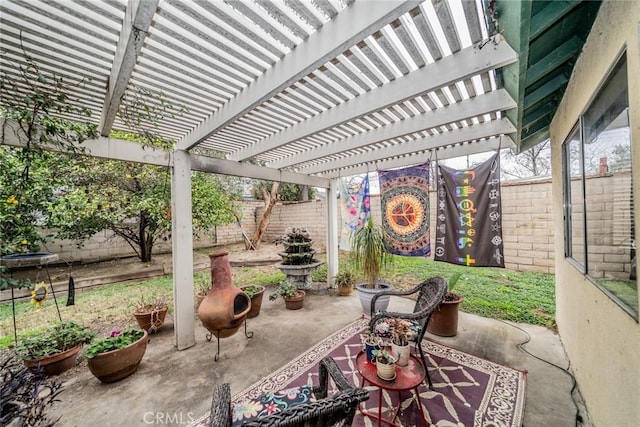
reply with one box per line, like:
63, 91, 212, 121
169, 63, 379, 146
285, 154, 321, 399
551, 1, 640, 426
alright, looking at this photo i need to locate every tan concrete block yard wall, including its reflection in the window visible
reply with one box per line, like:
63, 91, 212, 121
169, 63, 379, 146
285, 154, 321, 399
48, 172, 630, 277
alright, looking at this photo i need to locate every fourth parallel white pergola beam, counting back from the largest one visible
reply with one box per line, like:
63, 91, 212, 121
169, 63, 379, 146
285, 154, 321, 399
300, 118, 516, 174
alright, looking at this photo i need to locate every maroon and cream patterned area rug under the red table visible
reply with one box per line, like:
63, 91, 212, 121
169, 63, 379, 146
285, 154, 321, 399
192, 319, 526, 427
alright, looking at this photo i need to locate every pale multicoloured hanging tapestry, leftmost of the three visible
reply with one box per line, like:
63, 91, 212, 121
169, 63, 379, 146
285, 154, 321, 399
338, 175, 371, 251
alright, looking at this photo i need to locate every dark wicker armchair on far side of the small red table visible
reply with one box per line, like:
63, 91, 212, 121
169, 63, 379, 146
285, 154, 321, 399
369, 277, 447, 389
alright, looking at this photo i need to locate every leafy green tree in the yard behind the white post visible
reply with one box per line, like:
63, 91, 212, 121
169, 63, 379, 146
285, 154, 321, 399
49, 147, 237, 262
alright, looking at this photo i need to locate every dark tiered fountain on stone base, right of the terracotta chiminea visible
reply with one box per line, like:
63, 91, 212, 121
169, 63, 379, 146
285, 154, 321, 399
276, 228, 322, 289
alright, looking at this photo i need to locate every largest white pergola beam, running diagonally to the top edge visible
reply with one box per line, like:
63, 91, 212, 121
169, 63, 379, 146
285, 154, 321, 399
178, 0, 420, 150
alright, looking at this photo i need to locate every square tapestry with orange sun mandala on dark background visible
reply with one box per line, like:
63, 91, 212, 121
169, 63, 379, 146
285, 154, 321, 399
378, 162, 431, 256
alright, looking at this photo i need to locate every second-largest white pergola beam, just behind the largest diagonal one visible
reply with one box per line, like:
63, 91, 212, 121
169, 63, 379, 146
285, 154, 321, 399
228, 41, 518, 161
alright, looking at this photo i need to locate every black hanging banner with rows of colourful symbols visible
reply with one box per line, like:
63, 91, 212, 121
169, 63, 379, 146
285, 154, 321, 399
434, 154, 504, 267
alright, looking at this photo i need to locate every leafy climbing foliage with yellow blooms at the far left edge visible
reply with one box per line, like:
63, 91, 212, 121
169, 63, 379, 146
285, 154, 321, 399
0, 42, 97, 255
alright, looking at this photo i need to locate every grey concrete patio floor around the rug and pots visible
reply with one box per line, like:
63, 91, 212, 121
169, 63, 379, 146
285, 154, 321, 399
18, 247, 589, 427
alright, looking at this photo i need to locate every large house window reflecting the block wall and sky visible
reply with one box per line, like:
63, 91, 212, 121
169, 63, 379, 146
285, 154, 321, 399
563, 55, 638, 319
